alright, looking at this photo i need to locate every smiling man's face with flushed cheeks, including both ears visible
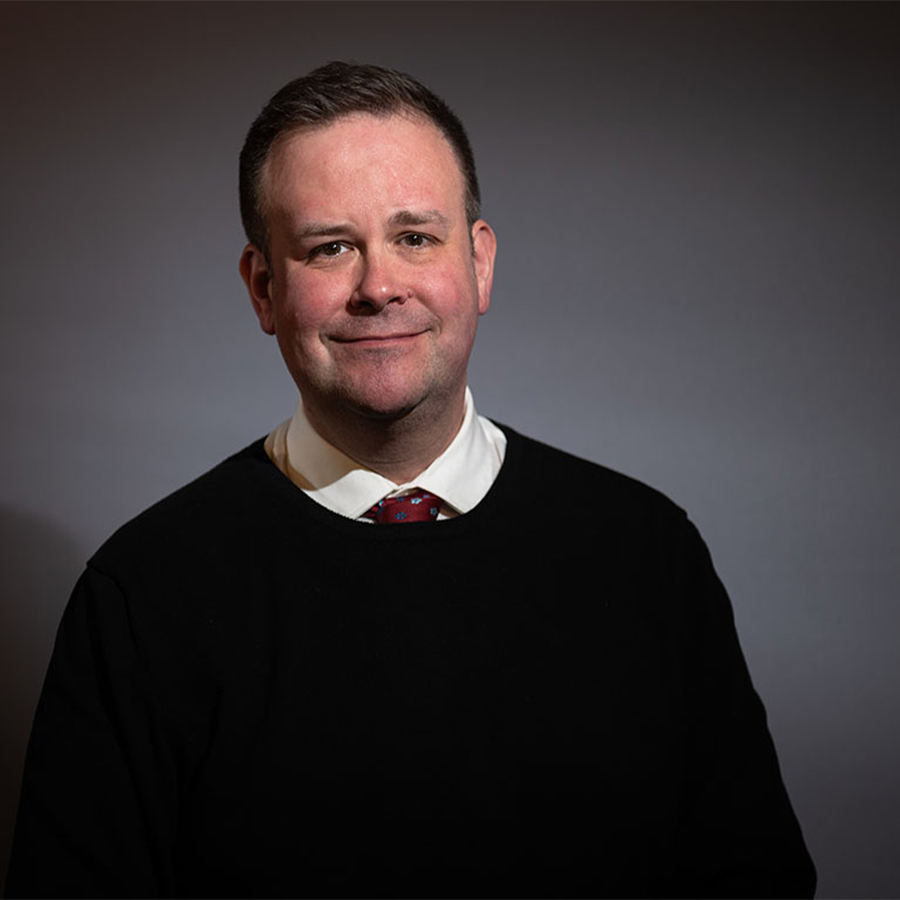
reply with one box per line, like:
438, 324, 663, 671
241, 114, 495, 434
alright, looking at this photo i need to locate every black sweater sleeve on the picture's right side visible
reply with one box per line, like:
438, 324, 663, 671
670, 523, 816, 897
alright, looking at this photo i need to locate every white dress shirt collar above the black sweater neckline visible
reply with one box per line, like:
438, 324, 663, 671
265, 388, 506, 522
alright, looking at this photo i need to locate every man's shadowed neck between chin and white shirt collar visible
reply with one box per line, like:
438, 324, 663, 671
304, 392, 465, 484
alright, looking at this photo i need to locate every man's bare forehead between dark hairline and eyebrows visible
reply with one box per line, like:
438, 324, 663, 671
262, 113, 464, 221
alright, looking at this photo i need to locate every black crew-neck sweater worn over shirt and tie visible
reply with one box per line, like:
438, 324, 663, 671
7, 429, 815, 897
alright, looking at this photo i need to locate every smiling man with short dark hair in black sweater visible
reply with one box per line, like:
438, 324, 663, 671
8, 63, 815, 897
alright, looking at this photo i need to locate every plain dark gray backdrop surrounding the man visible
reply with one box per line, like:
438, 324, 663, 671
0, 2, 900, 897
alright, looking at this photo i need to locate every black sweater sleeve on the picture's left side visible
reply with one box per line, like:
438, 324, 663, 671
6, 568, 177, 897
